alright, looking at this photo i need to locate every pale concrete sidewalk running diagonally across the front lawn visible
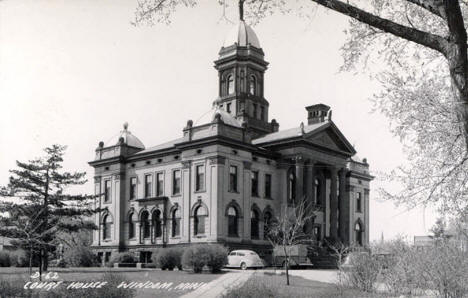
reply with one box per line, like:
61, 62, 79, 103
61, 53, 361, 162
181, 270, 254, 298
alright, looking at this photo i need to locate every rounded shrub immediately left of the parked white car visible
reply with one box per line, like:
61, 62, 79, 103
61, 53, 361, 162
182, 244, 228, 273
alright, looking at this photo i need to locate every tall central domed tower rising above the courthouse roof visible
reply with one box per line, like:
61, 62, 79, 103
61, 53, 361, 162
214, 0, 273, 137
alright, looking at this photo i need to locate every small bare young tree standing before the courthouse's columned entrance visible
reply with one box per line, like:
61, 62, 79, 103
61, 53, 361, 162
268, 199, 315, 286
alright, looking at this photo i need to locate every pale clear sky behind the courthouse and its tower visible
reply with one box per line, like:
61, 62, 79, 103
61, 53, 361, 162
0, 0, 434, 240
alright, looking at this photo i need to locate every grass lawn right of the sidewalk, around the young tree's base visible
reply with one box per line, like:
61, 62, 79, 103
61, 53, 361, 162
224, 273, 379, 298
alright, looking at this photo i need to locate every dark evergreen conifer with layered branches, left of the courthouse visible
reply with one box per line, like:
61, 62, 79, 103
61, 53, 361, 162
0, 145, 96, 272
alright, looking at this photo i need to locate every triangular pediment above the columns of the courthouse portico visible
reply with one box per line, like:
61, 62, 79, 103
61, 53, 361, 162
305, 124, 356, 155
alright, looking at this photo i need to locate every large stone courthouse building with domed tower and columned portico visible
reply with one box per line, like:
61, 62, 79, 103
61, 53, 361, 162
89, 20, 372, 262
